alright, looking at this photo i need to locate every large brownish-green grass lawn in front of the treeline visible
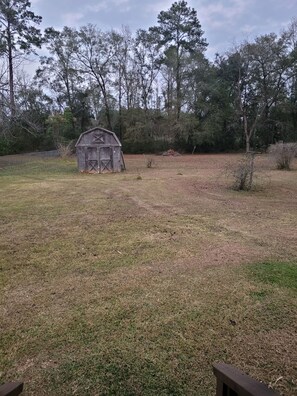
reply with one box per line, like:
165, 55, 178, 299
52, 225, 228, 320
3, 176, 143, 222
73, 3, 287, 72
0, 155, 297, 396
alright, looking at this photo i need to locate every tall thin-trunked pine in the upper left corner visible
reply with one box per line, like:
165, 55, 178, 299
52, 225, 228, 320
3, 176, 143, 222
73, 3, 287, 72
0, 0, 42, 115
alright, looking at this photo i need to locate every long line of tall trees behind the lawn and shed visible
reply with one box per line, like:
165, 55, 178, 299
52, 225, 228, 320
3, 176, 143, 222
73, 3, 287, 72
0, 0, 297, 154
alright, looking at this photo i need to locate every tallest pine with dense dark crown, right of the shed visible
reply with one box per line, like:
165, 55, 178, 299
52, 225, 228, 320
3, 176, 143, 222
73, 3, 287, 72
149, 0, 207, 120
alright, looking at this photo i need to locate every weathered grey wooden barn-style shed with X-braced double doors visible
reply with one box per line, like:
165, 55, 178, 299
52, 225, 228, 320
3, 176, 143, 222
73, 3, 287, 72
75, 127, 125, 173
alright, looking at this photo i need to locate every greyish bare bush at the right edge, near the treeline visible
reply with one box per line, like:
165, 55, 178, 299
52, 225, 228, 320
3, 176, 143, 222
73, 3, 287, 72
268, 143, 297, 170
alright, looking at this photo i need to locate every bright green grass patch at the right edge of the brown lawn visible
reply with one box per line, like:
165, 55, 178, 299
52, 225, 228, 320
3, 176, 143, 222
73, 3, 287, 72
248, 262, 297, 291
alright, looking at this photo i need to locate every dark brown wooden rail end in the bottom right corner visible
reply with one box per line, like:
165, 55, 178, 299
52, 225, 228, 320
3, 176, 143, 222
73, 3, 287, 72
213, 363, 279, 396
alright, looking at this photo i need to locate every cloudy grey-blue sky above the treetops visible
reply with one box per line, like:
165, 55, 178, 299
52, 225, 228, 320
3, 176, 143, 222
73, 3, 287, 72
31, 0, 297, 59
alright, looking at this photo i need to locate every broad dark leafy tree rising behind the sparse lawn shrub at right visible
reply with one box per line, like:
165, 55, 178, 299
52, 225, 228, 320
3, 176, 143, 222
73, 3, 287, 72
223, 33, 291, 152
